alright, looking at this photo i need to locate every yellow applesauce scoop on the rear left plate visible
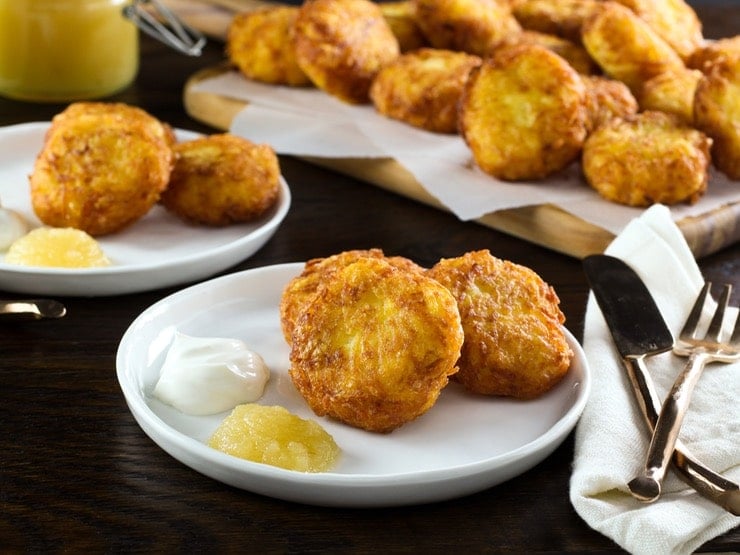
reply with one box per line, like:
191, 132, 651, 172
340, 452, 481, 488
5, 227, 110, 268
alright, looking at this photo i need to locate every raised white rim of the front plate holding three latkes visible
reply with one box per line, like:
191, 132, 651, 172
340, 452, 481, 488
116, 262, 593, 507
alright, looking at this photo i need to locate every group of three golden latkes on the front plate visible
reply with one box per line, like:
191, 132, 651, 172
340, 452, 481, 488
280, 249, 573, 432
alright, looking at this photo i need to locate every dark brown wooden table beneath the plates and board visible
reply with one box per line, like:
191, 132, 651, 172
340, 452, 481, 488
0, 7, 740, 553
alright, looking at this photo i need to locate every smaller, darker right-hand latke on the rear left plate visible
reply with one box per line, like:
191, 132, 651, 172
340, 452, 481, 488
161, 133, 280, 226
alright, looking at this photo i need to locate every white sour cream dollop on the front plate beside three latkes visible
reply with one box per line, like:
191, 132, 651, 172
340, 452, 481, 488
153, 332, 270, 416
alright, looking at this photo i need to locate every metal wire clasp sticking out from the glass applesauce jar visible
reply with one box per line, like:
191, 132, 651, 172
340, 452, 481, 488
123, 0, 206, 56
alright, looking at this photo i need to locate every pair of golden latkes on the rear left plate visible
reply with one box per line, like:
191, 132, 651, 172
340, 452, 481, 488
29, 102, 280, 236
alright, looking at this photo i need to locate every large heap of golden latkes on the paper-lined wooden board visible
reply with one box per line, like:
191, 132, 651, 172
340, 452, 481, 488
226, 0, 740, 206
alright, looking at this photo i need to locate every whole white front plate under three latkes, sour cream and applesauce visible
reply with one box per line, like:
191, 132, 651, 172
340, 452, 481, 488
116, 263, 591, 507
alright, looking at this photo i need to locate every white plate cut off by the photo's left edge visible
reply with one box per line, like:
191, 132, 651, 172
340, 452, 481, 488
0, 122, 290, 296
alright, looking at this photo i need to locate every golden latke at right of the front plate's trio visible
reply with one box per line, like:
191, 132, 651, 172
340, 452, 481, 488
427, 250, 573, 399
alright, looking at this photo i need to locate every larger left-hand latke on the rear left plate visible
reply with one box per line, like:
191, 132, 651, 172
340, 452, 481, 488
30, 102, 174, 236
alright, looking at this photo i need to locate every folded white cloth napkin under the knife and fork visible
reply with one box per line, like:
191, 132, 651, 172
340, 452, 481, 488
570, 205, 740, 554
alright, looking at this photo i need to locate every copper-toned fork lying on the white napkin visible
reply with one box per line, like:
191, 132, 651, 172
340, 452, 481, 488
628, 282, 740, 502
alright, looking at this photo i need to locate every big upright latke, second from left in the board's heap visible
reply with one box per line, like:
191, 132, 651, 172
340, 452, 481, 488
293, 0, 400, 104
